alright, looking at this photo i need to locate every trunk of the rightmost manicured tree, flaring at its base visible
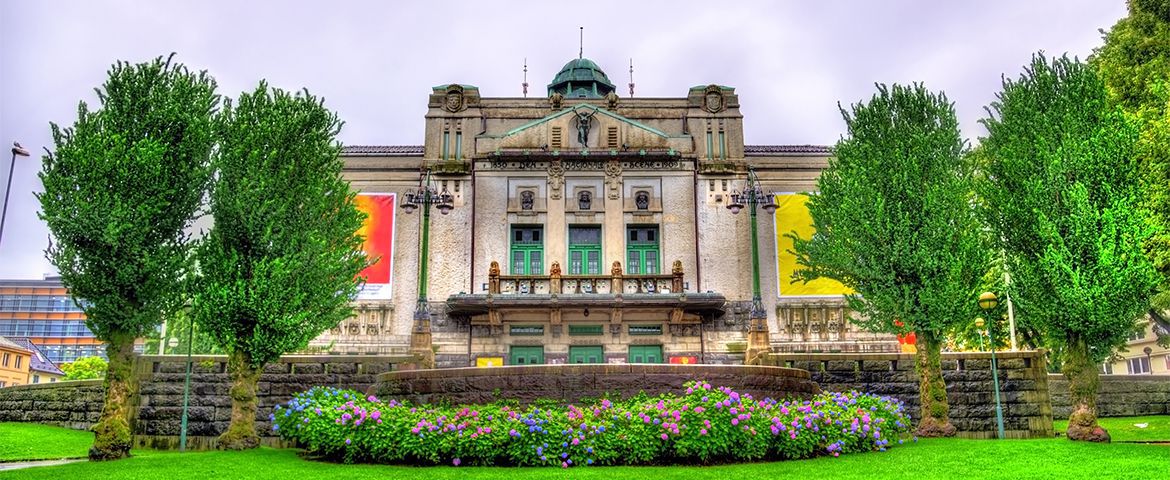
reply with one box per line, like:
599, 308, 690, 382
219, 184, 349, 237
1060, 334, 1109, 443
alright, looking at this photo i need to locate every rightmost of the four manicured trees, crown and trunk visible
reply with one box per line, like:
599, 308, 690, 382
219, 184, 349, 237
979, 55, 1157, 441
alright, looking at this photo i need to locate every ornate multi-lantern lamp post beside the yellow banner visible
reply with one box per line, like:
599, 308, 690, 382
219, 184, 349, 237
728, 166, 776, 364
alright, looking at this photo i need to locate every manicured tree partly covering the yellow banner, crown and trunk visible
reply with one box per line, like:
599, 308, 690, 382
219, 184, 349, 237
793, 84, 989, 436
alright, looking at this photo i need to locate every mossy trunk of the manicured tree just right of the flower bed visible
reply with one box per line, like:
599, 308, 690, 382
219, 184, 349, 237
914, 331, 955, 437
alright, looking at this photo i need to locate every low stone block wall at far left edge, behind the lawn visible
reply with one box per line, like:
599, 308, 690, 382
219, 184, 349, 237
0, 380, 105, 430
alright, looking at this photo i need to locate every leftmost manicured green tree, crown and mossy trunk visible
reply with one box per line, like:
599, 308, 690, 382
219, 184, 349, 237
37, 57, 219, 460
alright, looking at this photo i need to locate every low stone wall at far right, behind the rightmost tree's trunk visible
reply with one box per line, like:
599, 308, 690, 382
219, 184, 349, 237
1048, 375, 1170, 418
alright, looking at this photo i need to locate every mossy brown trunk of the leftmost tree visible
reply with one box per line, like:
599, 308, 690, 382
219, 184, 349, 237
89, 335, 137, 460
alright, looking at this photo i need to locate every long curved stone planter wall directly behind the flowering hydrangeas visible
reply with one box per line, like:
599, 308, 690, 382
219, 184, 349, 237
369, 364, 820, 404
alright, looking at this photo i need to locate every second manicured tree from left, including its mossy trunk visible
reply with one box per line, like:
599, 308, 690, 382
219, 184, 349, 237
192, 82, 366, 450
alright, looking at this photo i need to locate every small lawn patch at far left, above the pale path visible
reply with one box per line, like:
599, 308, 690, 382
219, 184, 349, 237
0, 423, 94, 462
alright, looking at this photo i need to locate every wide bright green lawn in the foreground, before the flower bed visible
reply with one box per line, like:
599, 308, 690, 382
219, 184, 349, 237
0, 438, 1170, 480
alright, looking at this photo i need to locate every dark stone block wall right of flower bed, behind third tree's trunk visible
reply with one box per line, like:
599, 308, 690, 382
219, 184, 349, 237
768, 351, 1054, 438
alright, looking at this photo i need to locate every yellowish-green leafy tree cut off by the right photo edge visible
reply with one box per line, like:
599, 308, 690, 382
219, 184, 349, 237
1089, 0, 1170, 325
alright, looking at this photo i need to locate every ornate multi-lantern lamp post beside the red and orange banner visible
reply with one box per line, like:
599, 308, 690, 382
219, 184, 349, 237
402, 169, 455, 369
